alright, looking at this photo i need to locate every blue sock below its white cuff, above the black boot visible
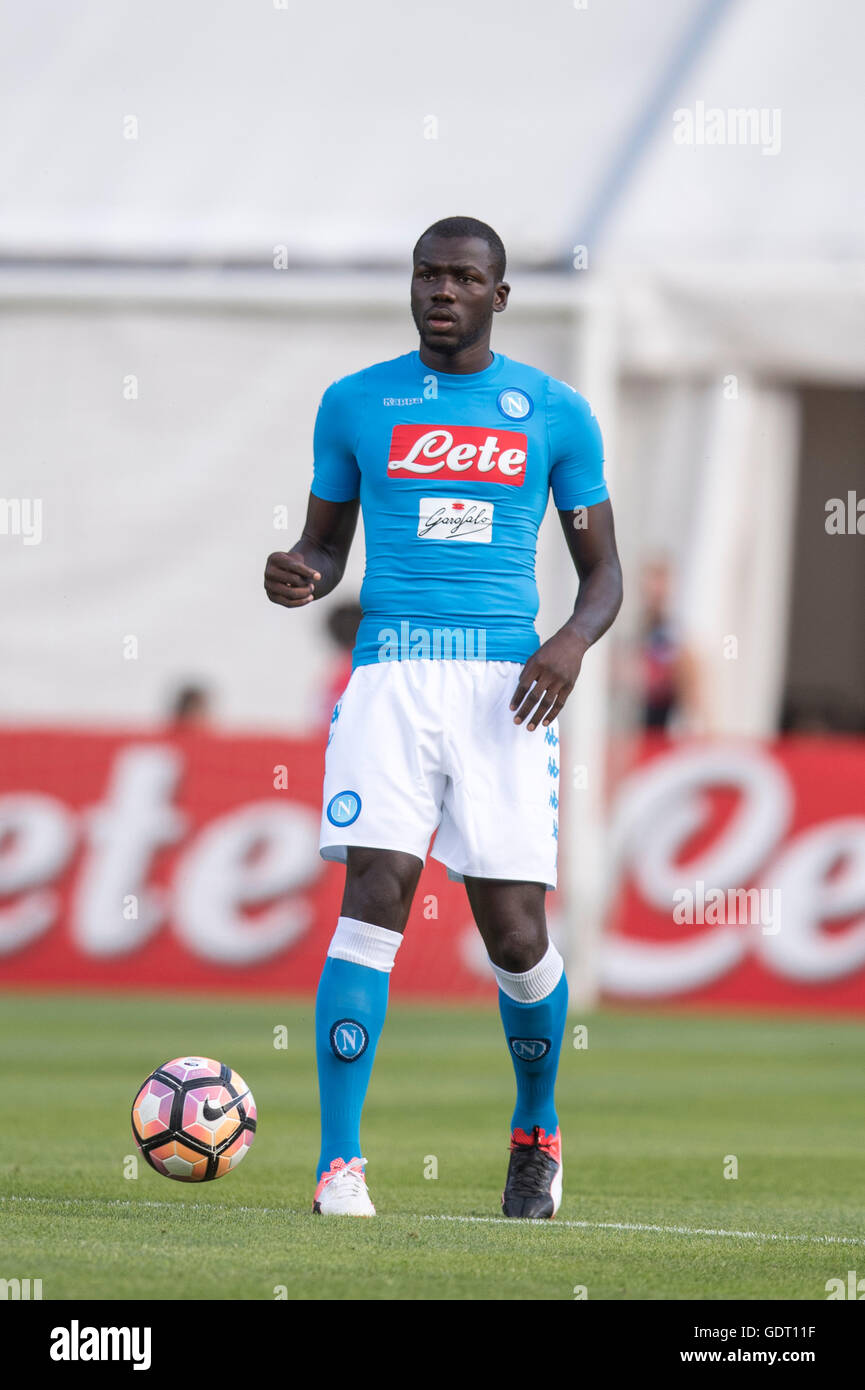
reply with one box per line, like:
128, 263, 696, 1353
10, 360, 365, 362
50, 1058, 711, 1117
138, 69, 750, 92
496, 947, 567, 1134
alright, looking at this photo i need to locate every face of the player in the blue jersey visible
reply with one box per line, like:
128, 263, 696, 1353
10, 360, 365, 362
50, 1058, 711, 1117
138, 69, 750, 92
412, 236, 508, 354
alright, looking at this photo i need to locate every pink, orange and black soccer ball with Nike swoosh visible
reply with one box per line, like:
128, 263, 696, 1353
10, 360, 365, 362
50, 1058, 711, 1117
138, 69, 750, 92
132, 1056, 256, 1183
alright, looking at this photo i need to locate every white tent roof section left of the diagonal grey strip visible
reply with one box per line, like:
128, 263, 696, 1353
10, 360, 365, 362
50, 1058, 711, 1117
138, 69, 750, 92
0, 0, 712, 263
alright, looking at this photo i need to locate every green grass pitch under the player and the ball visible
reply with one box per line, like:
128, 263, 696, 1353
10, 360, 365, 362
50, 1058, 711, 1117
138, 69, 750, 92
0, 995, 865, 1300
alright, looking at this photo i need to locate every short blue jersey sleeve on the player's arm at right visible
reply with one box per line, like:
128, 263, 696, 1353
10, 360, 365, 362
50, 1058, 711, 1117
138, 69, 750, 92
547, 379, 609, 512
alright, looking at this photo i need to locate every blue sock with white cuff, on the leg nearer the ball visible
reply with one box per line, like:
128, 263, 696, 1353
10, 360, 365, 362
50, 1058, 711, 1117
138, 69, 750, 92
316, 917, 402, 1179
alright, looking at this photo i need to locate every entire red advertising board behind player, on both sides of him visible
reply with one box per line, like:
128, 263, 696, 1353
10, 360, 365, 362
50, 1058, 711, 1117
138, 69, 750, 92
0, 728, 865, 1011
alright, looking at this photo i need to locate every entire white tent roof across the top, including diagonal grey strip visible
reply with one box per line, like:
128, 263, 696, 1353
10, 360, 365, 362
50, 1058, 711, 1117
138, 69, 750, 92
0, 0, 865, 267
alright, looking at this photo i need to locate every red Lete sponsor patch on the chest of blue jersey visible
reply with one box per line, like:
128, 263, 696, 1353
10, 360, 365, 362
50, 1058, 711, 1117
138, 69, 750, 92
388, 425, 528, 488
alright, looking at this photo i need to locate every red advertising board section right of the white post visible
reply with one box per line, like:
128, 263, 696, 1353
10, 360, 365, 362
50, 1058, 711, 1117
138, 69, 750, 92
601, 737, 865, 1011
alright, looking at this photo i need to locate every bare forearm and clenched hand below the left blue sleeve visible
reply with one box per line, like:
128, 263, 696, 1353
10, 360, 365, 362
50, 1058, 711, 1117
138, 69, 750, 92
264, 492, 360, 607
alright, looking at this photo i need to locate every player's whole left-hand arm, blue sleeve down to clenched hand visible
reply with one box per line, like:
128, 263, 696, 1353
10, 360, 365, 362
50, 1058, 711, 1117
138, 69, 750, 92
264, 373, 363, 607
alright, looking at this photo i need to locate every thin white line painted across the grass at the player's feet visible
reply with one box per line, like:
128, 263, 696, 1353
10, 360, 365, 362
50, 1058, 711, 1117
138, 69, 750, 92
0, 1195, 865, 1245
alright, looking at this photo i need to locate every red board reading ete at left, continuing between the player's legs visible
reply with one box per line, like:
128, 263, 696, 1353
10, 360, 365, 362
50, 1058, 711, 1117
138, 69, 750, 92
0, 730, 494, 998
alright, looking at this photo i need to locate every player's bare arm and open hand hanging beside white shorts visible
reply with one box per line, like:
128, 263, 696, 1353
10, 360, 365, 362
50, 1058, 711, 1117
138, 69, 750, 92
510, 498, 622, 730
